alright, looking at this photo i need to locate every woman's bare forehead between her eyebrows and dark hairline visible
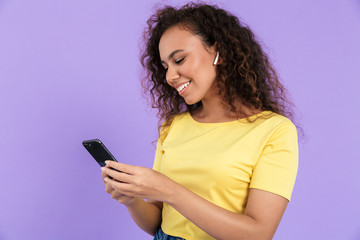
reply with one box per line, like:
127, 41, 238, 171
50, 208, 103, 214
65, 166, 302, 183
159, 26, 204, 59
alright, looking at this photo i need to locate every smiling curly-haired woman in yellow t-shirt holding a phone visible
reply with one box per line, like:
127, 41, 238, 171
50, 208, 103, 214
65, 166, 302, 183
102, 3, 298, 240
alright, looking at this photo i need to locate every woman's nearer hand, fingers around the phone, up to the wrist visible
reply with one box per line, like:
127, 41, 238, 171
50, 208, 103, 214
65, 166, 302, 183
102, 161, 178, 202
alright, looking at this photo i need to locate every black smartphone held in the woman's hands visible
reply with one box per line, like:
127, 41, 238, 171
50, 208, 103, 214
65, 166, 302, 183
82, 139, 117, 167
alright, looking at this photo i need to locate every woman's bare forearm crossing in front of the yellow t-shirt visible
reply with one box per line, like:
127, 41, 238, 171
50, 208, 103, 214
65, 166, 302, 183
168, 185, 264, 240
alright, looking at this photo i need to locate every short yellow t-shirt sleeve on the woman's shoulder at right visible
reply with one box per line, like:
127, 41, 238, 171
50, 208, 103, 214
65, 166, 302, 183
250, 122, 299, 201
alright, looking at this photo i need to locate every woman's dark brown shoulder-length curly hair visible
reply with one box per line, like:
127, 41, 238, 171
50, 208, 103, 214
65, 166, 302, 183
141, 3, 304, 141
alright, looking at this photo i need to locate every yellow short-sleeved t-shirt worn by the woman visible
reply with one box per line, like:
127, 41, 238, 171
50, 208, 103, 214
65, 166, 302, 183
153, 111, 298, 240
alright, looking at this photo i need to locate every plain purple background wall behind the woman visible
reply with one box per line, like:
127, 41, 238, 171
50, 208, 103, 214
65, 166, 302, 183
0, 0, 360, 240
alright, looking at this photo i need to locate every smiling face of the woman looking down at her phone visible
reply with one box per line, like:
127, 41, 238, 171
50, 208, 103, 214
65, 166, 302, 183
159, 26, 217, 105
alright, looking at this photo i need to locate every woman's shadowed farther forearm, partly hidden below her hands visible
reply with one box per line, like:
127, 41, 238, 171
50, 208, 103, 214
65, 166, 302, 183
126, 198, 162, 236
